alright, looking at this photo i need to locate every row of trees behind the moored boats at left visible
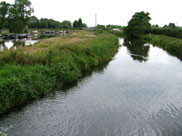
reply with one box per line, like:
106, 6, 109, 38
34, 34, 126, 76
0, 0, 87, 33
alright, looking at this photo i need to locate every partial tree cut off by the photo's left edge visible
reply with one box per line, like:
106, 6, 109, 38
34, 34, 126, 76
0, 1, 10, 31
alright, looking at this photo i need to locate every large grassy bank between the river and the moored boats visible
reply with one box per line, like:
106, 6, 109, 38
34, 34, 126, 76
0, 32, 119, 114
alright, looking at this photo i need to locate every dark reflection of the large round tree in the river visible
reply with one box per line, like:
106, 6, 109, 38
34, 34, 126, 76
124, 40, 150, 62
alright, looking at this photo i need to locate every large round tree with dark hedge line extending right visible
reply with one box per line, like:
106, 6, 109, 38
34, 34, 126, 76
124, 11, 182, 40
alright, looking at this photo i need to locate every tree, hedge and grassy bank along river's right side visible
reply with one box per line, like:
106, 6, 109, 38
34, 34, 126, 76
124, 11, 182, 60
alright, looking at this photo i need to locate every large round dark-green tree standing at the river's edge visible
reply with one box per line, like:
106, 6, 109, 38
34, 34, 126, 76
124, 11, 151, 39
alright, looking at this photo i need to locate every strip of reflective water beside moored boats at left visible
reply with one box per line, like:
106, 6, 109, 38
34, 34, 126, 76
0, 39, 38, 52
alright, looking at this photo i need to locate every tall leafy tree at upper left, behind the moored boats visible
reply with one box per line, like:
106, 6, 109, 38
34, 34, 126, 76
8, 0, 33, 33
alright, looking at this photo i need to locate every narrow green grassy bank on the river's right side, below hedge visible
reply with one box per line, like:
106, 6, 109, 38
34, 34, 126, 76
143, 35, 182, 60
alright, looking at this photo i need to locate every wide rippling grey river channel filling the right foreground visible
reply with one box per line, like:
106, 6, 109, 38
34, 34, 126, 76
0, 39, 182, 136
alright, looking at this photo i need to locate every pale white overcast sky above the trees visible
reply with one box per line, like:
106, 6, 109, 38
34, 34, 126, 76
0, 0, 182, 26
